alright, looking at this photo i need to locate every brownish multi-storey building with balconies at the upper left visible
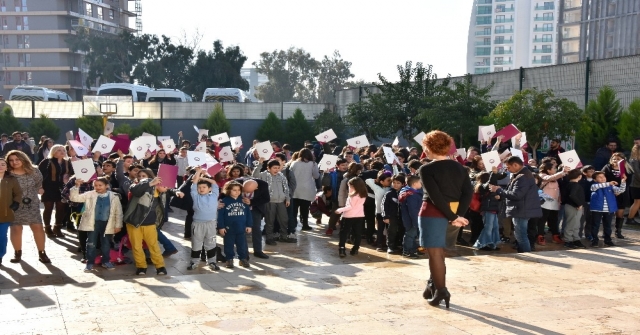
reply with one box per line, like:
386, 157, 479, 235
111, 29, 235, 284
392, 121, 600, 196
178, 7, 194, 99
0, 0, 136, 100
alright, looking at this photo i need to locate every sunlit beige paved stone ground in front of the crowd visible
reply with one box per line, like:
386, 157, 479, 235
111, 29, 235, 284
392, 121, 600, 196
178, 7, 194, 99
0, 210, 640, 335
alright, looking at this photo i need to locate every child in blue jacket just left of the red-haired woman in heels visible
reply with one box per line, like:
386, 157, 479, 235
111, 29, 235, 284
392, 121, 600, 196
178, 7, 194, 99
398, 176, 423, 258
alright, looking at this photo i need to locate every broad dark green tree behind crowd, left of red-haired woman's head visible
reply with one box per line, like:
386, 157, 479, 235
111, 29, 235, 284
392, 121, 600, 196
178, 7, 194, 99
346, 62, 449, 141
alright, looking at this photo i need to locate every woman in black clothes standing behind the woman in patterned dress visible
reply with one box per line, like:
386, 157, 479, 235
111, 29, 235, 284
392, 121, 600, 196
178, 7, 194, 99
38, 144, 73, 237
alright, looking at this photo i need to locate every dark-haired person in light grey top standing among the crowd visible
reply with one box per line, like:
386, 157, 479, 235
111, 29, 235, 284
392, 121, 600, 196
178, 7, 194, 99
291, 148, 320, 230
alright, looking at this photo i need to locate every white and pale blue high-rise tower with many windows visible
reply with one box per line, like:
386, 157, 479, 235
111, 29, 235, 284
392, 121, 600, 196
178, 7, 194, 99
467, 0, 559, 74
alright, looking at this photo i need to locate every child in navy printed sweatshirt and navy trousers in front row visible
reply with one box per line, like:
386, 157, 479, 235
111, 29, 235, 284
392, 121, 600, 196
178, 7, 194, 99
218, 181, 253, 269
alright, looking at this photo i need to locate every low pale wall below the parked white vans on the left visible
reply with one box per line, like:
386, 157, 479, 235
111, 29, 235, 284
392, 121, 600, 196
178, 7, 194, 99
6, 101, 333, 120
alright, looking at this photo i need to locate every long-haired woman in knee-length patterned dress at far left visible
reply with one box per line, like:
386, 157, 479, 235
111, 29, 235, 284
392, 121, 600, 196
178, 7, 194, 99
5, 150, 51, 263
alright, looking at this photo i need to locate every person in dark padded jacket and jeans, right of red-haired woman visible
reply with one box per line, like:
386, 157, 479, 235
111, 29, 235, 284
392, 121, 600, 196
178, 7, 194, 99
490, 156, 542, 252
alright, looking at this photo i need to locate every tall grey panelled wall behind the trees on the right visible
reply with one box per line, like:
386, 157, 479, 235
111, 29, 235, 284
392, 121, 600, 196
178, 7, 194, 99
335, 55, 640, 115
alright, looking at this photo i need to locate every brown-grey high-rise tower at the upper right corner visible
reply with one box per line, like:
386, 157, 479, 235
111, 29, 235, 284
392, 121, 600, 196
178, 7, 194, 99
557, 0, 640, 63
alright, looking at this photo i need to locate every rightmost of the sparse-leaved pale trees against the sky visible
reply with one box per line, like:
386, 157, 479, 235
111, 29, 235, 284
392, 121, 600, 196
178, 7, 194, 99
318, 50, 355, 103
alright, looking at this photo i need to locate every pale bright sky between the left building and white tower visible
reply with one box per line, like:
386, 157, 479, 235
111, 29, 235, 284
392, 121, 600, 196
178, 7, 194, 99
145, 0, 473, 81
